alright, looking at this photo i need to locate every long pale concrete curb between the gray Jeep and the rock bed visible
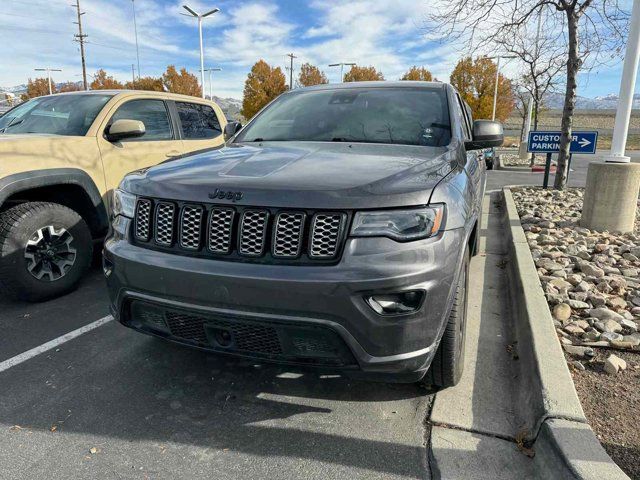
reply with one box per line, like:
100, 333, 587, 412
503, 187, 629, 480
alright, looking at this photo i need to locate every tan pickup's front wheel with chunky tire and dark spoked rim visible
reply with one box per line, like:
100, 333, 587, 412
0, 202, 93, 302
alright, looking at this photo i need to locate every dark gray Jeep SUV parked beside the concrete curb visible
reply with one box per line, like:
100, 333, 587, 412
104, 82, 502, 387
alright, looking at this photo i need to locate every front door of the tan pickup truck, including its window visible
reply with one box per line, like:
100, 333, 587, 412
98, 99, 184, 190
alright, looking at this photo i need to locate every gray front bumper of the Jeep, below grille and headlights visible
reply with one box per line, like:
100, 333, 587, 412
104, 218, 465, 381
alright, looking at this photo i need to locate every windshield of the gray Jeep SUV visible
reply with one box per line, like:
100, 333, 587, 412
235, 87, 451, 146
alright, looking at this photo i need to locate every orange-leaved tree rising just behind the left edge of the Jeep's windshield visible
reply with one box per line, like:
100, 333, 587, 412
241, 60, 287, 120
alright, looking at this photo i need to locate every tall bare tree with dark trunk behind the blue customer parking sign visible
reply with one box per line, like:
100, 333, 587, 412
428, 0, 629, 189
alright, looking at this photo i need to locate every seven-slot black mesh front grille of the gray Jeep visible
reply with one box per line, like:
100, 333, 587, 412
133, 198, 349, 264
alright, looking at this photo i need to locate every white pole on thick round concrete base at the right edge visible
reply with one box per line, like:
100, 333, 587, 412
580, 0, 640, 233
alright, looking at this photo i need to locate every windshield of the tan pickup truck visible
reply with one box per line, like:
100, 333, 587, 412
0, 94, 113, 136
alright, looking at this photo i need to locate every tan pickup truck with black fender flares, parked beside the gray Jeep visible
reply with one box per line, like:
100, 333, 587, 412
0, 90, 240, 301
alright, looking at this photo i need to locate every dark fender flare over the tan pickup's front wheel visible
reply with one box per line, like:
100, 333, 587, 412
0, 168, 109, 235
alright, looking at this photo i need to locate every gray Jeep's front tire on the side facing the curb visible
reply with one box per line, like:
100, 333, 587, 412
424, 249, 469, 388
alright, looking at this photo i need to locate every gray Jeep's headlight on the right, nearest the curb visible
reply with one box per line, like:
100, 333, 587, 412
351, 205, 444, 242
